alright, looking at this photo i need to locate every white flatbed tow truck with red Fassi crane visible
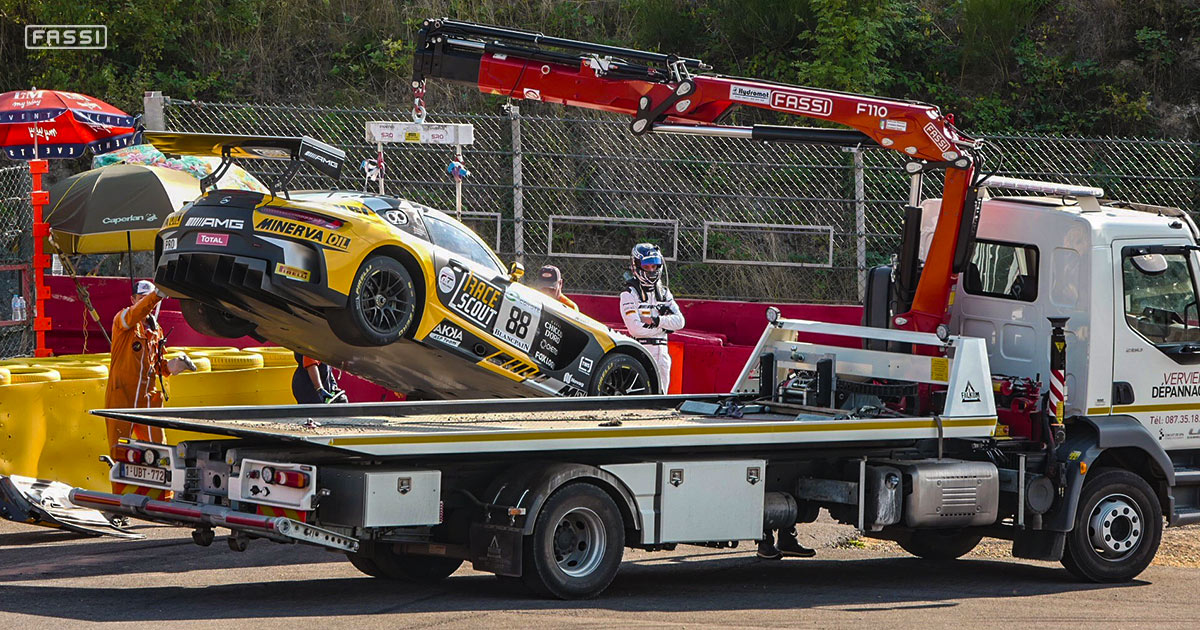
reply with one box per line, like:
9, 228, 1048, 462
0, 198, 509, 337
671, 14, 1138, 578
0, 20, 1200, 598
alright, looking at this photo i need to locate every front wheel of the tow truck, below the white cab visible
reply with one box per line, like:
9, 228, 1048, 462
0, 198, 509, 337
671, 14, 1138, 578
1062, 468, 1163, 582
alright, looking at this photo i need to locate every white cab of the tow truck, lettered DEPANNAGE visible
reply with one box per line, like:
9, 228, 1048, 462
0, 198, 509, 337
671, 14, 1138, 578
922, 197, 1200, 524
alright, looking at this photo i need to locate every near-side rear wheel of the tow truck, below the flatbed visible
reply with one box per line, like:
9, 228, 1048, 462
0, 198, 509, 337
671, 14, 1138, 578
521, 484, 625, 599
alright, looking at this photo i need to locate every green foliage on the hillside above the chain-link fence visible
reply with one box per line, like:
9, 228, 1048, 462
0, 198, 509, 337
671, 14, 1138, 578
0, 0, 1200, 138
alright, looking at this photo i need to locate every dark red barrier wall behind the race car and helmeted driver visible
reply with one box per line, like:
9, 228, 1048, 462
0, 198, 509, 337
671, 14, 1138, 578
46, 276, 863, 393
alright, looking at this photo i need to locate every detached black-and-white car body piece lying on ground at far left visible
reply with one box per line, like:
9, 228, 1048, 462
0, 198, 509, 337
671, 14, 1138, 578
0, 475, 145, 539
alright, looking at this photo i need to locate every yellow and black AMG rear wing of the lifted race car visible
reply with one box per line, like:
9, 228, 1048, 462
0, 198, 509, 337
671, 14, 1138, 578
145, 131, 346, 192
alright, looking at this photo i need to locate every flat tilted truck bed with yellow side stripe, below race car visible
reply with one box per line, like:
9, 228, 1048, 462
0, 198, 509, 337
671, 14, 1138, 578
96, 395, 996, 457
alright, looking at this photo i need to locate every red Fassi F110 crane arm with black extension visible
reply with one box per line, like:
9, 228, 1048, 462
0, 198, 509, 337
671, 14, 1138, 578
413, 19, 978, 331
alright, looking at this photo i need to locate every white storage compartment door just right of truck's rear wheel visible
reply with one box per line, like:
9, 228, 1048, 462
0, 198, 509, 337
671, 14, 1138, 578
658, 460, 767, 542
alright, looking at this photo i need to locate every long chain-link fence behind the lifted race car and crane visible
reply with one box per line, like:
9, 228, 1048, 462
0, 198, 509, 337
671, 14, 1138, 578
159, 100, 1200, 304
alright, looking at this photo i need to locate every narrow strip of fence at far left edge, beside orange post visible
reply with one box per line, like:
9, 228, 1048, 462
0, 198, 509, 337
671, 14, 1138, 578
0, 164, 34, 359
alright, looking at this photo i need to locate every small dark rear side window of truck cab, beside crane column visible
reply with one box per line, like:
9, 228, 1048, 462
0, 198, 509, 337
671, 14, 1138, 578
962, 240, 1038, 302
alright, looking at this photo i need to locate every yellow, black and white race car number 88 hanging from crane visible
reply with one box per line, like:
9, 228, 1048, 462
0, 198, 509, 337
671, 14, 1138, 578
148, 132, 660, 398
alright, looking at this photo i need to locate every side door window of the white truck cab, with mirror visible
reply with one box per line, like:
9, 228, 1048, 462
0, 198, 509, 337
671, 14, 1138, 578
1121, 253, 1200, 345
